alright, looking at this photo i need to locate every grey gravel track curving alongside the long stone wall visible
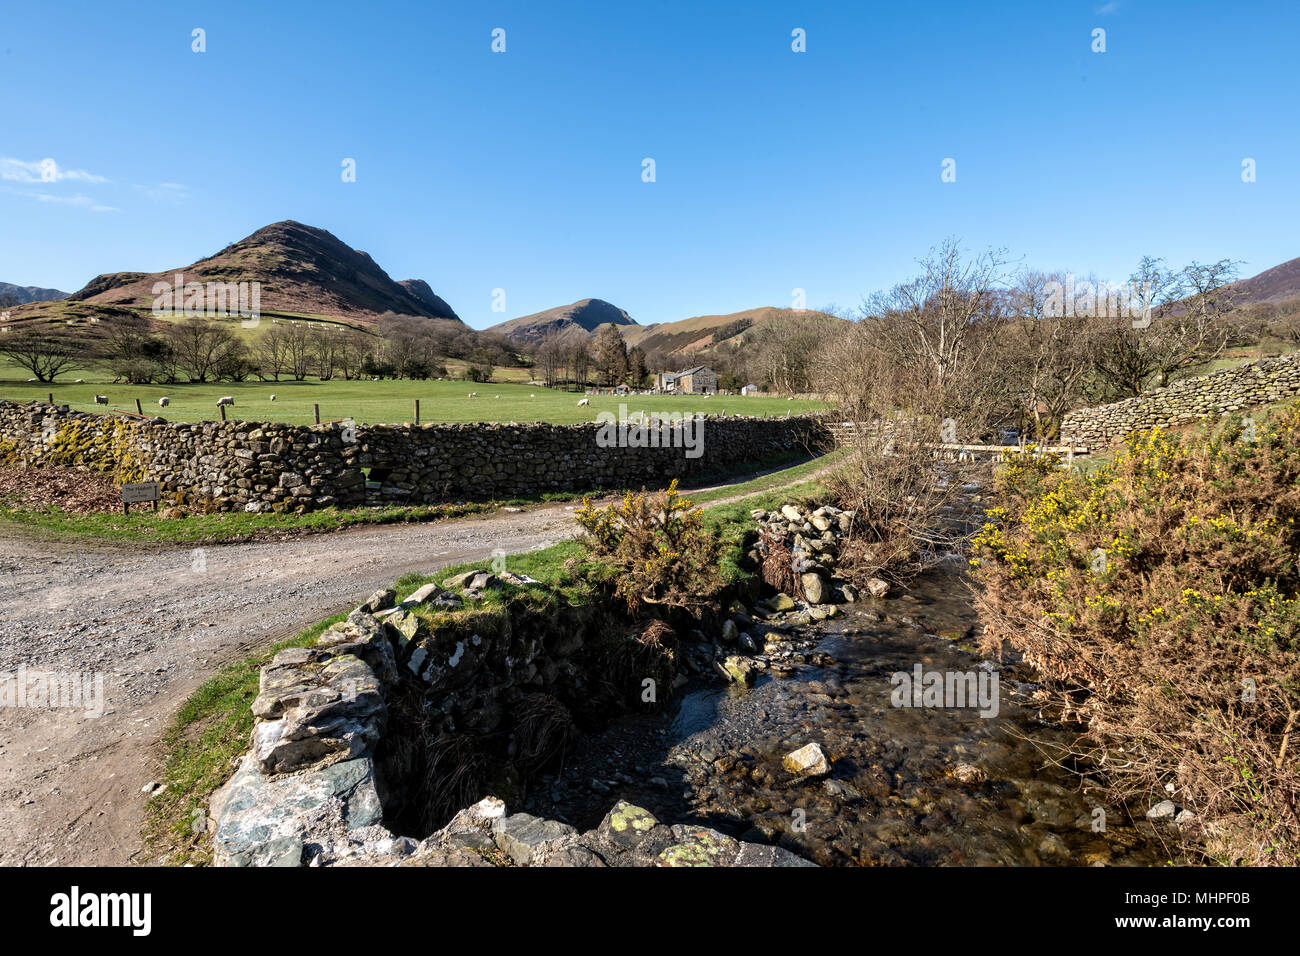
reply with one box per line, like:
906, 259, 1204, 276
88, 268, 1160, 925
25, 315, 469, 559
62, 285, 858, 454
0, 463, 811, 866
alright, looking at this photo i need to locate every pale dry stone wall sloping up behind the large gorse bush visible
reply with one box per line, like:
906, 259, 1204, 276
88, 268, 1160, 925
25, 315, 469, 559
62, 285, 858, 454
1061, 354, 1300, 449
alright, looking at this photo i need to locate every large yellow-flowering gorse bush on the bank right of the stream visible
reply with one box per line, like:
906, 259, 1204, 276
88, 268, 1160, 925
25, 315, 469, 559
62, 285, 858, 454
971, 411, 1300, 865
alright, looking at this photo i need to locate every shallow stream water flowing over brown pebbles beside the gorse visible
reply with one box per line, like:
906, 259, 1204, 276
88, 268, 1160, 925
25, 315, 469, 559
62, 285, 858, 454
527, 566, 1177, 865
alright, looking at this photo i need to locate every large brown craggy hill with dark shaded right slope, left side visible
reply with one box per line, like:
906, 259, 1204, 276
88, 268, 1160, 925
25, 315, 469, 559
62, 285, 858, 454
69, 220, 460, 325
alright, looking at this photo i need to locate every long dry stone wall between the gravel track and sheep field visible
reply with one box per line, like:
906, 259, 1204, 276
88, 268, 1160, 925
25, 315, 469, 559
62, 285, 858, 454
0, 401, 826, 511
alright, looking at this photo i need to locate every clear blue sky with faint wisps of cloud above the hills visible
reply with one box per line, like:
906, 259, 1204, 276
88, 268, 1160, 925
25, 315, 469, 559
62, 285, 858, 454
0, 0, 1300, 328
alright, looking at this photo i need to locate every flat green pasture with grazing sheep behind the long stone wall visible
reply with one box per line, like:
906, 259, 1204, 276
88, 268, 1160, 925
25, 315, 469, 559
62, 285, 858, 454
0, 367, 823, 424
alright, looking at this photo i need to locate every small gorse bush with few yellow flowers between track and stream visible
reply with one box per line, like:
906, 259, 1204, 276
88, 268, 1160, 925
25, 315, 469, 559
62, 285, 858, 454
575, 480, 720, 613
